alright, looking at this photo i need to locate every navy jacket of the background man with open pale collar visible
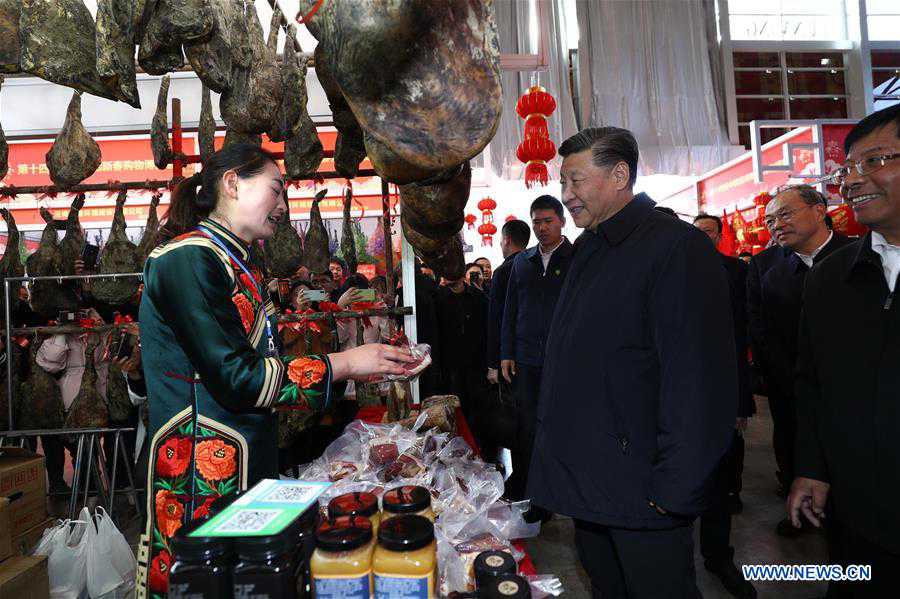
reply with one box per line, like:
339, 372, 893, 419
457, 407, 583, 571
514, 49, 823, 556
500, 239, 572, 367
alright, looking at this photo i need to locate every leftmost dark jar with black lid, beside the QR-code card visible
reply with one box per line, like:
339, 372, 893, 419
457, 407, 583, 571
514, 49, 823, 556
168, 521, 233, 599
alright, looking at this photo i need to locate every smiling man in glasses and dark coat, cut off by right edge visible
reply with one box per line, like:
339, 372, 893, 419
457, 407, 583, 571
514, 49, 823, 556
788, 106, 900, 599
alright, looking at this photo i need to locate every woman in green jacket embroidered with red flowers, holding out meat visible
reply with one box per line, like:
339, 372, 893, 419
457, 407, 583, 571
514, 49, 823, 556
137, 144, 411, 598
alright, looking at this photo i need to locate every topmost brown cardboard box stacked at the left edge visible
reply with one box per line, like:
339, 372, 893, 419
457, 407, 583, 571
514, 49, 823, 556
0, 447, 47, 537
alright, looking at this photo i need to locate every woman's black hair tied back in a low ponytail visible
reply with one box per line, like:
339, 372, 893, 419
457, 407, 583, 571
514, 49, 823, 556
160, 144, 277, 241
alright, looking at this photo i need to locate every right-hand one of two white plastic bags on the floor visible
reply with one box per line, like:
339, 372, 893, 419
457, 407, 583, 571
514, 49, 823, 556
86, 507, 137, 599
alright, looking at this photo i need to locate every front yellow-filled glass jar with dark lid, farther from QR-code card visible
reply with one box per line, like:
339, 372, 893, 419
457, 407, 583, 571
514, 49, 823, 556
372, 515, 437, 599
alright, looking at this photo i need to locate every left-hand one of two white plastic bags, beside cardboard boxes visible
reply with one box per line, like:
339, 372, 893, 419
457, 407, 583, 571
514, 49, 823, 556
34, 508, 95, 599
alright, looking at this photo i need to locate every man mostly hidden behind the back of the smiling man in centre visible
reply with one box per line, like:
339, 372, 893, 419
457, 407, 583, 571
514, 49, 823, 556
694, 214, 756, 598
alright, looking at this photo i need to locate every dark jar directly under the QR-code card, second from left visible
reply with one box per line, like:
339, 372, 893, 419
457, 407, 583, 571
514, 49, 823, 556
232, 529, 308, 599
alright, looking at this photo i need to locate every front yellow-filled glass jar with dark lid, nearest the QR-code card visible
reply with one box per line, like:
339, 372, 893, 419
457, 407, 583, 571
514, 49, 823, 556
310, 516, 375, 599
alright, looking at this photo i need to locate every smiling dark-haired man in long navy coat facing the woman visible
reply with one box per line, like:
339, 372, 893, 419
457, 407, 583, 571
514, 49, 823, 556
528, 127, 738, 599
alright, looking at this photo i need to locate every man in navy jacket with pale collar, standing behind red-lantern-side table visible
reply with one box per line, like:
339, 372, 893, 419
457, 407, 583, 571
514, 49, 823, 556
500, 195, 572, 521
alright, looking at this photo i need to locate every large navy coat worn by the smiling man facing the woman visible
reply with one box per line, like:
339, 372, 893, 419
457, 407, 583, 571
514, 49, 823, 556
528, 194, 738, 529
